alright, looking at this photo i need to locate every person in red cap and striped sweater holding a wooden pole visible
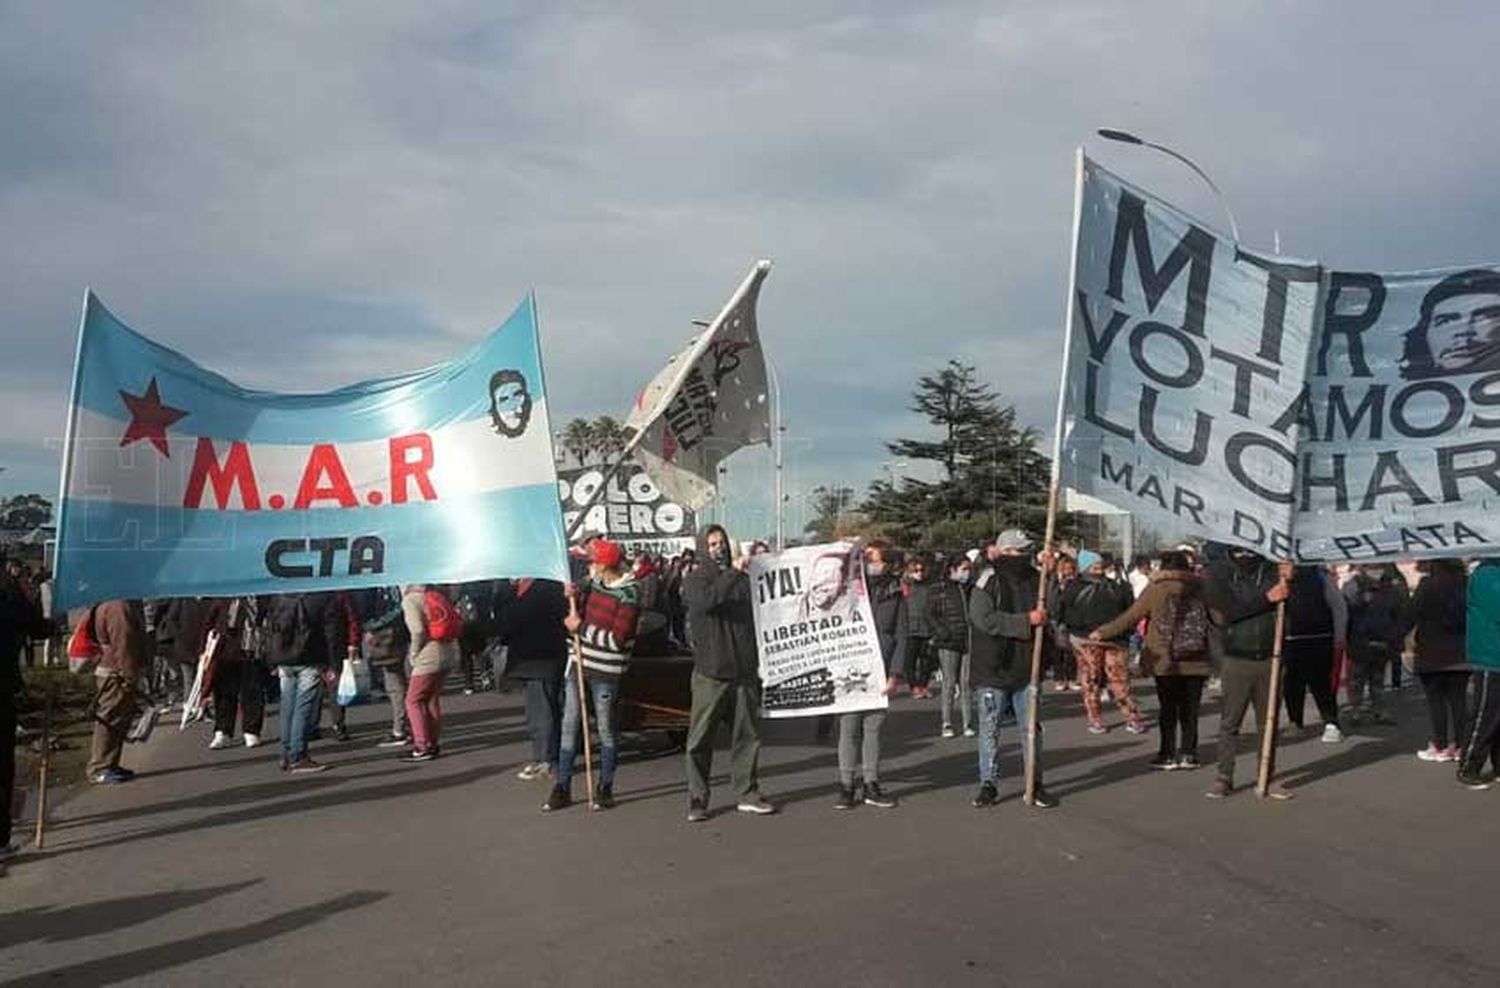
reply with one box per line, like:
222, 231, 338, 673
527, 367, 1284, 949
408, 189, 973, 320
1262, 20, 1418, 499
542, 538, 641, 811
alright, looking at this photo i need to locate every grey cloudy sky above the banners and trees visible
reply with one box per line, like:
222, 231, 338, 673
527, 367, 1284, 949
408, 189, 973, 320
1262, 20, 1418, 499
0, 0, 1500, 539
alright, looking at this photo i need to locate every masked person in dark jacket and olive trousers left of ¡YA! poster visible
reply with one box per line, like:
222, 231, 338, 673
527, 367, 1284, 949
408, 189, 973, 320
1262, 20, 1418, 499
683, 525, 776, 823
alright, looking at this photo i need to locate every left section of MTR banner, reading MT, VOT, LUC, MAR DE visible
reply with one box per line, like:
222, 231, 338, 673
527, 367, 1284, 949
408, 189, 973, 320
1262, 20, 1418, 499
1059, 156, 1322, 558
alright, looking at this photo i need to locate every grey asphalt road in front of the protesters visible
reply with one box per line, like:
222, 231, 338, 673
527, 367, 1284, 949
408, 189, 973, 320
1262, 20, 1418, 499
0, 687, 1500, 988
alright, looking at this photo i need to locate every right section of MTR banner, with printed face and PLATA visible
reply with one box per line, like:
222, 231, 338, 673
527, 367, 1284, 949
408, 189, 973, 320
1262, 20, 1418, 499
1292, 267, 1500, 562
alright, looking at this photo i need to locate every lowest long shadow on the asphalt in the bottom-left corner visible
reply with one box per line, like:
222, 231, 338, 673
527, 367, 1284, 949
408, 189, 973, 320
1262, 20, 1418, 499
0, 891, 390, 988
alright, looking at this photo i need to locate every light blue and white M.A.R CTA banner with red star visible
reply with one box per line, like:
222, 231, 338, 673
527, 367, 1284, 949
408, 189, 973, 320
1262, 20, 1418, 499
57, 294, 567, 607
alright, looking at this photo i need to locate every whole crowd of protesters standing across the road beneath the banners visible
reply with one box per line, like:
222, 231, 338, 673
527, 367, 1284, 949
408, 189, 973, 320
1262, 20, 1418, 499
0, 525, 1500, 849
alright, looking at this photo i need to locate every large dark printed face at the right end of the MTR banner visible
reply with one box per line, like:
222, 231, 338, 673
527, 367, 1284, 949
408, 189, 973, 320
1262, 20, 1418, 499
1401, 270, 1500, 381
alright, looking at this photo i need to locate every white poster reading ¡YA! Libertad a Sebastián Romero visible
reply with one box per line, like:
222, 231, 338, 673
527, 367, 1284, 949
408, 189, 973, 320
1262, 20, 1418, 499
750, 543, 888, 717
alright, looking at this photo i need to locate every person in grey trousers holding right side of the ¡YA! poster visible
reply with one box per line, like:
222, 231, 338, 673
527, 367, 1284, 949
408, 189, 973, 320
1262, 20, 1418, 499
834, 540, 911, 810
